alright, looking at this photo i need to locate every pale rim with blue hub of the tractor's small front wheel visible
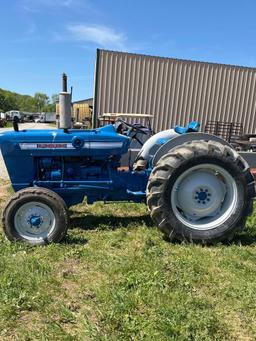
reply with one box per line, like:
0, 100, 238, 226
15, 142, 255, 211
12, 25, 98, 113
14, 201, 56, 241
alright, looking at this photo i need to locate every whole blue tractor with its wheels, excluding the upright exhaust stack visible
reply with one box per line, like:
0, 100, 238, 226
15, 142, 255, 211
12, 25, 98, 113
0, 115, 255, 244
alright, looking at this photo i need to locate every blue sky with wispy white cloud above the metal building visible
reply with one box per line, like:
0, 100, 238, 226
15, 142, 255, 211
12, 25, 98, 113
0, 0, 256, 100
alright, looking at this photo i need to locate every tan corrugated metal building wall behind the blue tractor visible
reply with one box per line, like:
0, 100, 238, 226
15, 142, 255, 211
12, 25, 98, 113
93, 50, 256, 133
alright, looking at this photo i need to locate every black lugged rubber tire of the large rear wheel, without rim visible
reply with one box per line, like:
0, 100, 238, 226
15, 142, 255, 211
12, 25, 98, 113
147, 140, 255, 244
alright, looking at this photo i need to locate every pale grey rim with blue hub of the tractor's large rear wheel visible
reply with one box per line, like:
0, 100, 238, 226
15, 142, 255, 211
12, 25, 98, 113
171, 164, 238, 230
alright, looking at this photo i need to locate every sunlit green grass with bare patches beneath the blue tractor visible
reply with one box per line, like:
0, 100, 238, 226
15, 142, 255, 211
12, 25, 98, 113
0, 183, 256, 341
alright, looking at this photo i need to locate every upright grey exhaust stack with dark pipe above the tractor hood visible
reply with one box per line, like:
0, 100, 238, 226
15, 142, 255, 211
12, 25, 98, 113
59, 73, 71, 131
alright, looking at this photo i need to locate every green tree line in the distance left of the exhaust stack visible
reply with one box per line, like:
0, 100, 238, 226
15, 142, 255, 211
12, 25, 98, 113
0, 89, 58, 112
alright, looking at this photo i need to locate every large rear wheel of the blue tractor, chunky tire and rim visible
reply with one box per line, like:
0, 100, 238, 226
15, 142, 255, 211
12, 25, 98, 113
147, 141, 255, 244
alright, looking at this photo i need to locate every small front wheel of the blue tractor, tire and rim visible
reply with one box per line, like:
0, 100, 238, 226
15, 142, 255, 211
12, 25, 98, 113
3, 188, 68, 245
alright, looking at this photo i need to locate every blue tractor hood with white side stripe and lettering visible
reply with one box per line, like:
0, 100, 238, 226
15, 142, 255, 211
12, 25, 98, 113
0, 125, 130, 159
